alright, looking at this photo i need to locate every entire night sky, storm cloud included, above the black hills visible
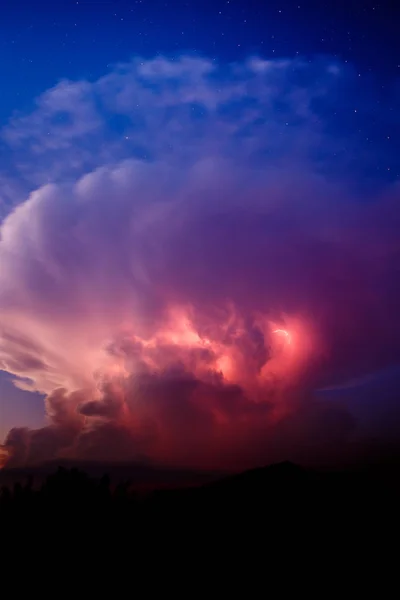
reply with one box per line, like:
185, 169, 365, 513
0, 0, 400, 468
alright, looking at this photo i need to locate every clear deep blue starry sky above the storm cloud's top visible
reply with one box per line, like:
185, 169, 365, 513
0, 0, 400, 117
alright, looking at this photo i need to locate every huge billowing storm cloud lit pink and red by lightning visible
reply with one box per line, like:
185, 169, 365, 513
0, 57, 400, 467
